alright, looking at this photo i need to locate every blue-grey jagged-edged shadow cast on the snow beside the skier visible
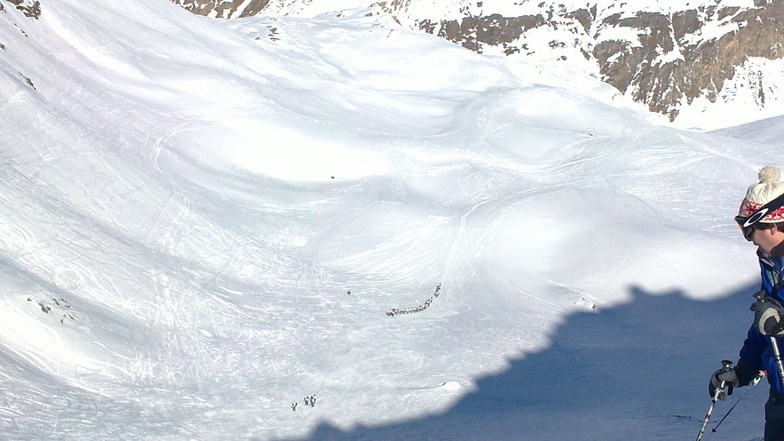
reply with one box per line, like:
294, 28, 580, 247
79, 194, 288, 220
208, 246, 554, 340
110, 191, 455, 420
274, 286, 767, 441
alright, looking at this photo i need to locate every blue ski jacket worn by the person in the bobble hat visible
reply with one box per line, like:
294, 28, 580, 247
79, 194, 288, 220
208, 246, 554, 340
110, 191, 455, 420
740, 257, 784, 394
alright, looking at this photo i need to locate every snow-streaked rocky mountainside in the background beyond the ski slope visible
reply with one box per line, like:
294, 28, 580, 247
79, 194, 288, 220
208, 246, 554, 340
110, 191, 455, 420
172, 0, 784, 127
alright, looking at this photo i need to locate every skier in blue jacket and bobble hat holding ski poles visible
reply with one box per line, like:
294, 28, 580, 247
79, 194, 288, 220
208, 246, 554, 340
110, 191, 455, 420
708, 167, 784, 441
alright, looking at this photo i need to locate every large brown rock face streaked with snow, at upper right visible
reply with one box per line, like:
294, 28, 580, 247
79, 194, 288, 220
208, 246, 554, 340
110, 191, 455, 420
593, 1, 784, 121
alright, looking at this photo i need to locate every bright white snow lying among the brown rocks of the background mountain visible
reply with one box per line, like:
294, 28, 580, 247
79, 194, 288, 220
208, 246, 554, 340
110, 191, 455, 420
260, 0, 784, 130
